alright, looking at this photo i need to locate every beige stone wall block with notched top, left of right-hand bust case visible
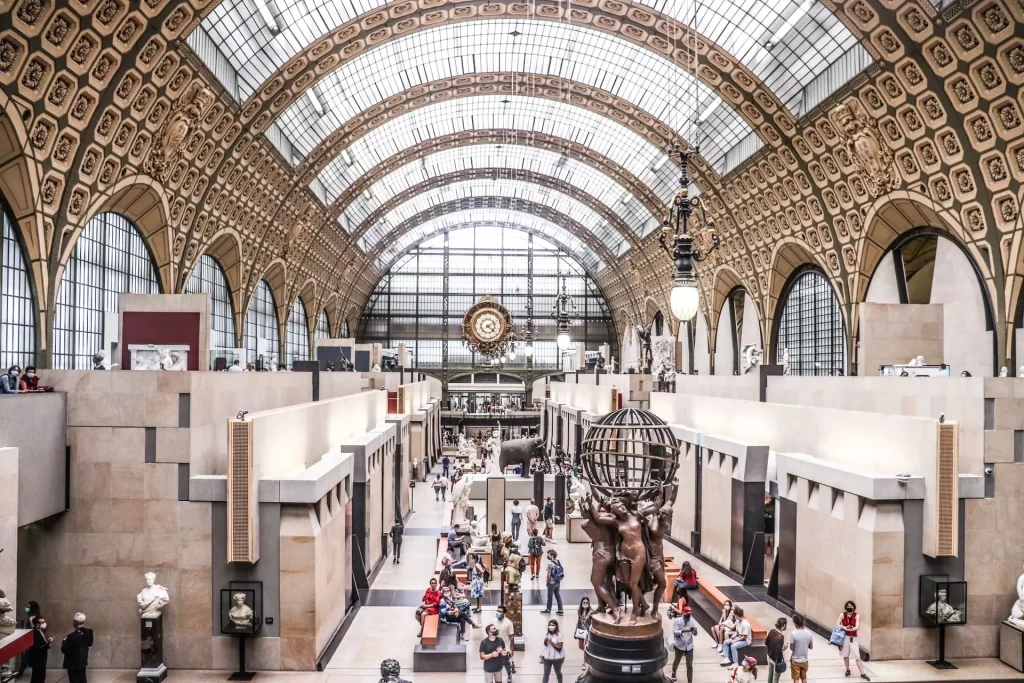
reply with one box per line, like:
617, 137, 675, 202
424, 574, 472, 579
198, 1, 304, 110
790, 479, 904, 659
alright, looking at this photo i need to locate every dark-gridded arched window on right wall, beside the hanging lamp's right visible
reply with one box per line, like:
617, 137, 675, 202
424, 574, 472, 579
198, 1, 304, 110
775, 270, 846, 375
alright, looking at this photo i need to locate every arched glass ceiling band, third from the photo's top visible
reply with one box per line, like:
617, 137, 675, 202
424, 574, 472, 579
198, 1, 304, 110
317, 95, 678, 204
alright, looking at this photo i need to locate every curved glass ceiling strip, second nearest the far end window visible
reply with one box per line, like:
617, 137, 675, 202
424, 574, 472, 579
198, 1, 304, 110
359, 178, 630, 256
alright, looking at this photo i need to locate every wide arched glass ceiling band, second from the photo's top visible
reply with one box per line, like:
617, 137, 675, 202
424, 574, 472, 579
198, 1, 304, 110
278, 19, 751, 168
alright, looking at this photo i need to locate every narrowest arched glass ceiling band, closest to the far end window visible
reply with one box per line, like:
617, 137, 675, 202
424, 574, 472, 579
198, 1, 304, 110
377, 214, 604, 273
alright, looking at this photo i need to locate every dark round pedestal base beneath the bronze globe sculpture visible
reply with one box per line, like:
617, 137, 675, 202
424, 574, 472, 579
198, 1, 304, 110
577, 611, 669, 683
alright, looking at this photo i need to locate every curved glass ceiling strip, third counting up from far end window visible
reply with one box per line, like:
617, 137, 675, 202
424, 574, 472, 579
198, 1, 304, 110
342, 144, 660, 239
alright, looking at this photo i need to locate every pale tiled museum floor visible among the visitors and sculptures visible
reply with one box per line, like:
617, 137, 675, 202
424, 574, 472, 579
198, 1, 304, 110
66, 466, 1024, 683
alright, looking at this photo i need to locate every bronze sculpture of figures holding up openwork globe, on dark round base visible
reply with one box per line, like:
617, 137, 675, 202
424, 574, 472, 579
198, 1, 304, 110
580, 409, 679, 683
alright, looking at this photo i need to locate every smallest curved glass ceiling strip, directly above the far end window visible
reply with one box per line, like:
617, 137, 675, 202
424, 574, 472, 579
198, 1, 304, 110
380, 218, 601, 279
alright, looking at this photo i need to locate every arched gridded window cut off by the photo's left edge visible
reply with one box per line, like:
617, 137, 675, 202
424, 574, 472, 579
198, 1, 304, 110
0, 205, 36, 372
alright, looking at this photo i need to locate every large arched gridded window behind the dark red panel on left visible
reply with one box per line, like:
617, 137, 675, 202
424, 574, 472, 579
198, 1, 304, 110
53, 212, 160, 370
